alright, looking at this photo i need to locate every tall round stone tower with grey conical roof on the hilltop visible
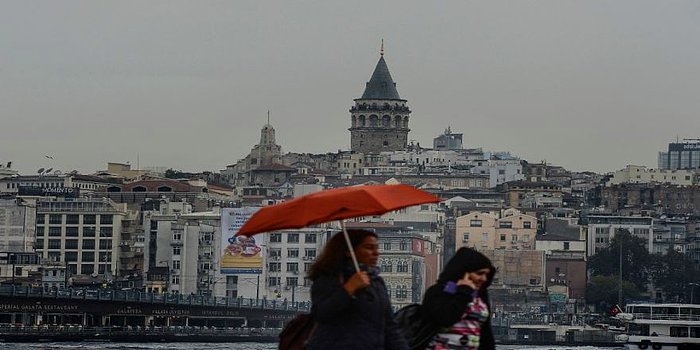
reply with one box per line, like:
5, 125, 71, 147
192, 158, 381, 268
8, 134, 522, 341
348, 40, 411, 154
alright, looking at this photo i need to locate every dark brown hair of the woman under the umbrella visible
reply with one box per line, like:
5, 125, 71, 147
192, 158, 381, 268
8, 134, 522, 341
308, 230, 378, 281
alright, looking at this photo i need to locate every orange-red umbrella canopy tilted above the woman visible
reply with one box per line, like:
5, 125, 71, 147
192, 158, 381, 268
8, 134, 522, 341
236, 185, 440, 236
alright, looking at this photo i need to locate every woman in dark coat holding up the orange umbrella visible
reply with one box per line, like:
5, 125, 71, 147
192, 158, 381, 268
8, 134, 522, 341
306, 230, 408, 350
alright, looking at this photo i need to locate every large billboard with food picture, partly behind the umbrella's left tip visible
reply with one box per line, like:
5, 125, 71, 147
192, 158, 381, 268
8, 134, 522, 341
219, 207, 263, 275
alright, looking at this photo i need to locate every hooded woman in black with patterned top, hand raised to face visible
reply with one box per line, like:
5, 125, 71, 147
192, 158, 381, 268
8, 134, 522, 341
420, 248, 496, 350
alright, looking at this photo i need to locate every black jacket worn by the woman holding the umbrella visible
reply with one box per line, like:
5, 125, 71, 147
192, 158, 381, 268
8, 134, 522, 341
307, 268, 408, 350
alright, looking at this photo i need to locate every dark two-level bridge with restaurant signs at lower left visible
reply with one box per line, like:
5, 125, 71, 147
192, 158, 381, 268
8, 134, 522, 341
0, 286, 310, 329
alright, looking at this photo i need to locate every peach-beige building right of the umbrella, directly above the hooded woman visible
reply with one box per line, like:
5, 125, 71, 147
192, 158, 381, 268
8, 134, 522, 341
455, 209, 537, 251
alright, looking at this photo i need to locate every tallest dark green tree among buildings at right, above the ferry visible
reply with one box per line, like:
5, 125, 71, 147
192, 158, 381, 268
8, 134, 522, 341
588, 229, 654, 290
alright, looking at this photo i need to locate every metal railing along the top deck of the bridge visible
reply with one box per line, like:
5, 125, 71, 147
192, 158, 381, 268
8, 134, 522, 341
0, 285, 310, 311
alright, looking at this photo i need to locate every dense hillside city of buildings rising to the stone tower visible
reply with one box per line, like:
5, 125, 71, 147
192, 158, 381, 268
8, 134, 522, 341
0, 51, 700, 334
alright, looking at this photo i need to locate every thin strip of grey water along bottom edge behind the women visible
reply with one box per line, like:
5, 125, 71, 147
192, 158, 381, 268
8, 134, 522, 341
0, 342, 621, 350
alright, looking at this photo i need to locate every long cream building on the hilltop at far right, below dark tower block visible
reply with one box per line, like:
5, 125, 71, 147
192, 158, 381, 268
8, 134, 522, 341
606, 165, 697, 186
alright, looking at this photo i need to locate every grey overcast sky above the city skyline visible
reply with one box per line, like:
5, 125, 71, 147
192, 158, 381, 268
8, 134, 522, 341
0, 0, 700, 174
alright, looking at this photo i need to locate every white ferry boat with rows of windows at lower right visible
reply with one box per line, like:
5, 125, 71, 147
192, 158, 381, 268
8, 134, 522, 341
615, 304, 700, 350
